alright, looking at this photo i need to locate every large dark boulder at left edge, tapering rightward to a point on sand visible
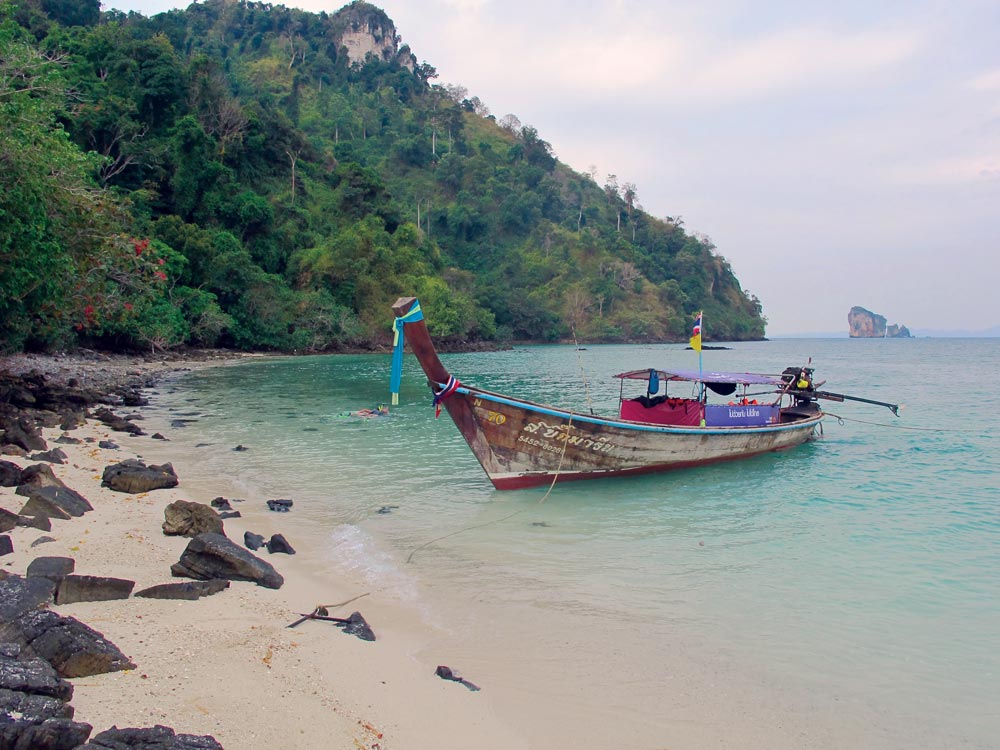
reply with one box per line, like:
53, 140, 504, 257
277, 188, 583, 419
0, 612, 135, 677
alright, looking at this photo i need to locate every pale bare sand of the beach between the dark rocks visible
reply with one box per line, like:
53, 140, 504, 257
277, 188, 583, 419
0, 362, 524, 750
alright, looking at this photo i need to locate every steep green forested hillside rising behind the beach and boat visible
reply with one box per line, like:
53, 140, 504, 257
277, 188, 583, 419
0, 0, 764, 351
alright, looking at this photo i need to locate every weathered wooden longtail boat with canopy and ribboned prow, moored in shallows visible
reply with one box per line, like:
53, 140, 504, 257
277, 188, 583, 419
392, 297, 899, 490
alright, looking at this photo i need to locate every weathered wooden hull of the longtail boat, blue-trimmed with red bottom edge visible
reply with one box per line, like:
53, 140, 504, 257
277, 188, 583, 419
445, 387, 822, 490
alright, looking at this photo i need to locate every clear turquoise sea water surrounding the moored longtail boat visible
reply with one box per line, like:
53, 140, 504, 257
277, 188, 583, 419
139, 339, 1000, 749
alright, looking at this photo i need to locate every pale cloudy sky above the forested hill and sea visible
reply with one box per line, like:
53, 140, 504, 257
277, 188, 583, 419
104, 0, 1000, 335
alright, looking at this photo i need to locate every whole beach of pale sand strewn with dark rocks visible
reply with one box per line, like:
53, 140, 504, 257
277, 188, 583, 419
0, 352, 517, 750
